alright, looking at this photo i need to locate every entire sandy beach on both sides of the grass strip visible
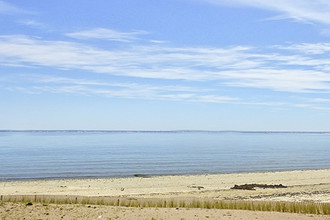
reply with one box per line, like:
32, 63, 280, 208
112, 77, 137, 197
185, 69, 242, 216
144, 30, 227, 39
0, 169, 330, 219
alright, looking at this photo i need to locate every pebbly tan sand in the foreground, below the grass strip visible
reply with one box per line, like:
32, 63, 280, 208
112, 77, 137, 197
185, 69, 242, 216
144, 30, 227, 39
0, 203, 329, 220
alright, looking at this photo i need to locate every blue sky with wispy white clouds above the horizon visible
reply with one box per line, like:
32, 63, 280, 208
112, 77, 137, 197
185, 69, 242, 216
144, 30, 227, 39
0, 0, 330, 131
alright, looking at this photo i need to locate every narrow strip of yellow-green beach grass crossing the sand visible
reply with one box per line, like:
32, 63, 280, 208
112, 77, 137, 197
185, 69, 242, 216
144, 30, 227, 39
1, 195, 330, 215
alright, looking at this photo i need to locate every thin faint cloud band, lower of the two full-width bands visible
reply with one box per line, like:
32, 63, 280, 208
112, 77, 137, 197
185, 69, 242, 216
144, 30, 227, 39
0, 74, 330, 111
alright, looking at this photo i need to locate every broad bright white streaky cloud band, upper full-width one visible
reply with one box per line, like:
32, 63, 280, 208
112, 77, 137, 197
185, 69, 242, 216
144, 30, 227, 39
0, 35, 330, 96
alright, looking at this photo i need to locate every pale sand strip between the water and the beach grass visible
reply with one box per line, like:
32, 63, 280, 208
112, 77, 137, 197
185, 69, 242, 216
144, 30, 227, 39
0, 169, 330, 203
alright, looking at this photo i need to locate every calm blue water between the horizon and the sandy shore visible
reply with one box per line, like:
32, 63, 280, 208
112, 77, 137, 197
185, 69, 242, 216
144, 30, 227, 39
0, 131, 330, 180
